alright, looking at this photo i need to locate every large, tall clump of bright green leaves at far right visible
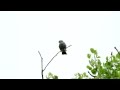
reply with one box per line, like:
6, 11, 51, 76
87, 48, 120, 79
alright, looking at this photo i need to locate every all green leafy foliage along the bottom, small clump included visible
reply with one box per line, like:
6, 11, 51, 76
46, 47, 120, 79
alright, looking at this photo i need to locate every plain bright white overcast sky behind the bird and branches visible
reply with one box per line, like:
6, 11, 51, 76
0, 11, 120, 79
